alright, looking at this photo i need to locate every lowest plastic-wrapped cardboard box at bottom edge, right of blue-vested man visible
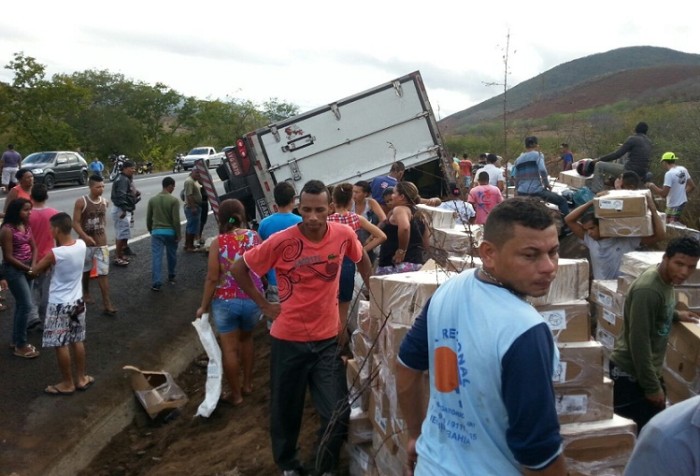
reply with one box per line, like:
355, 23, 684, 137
560, 415, 637, 476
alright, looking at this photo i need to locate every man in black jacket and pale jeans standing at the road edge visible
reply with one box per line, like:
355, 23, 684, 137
111, 159, 138, 266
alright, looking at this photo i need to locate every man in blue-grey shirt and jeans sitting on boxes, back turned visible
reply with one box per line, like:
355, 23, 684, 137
513, 136, 569, 216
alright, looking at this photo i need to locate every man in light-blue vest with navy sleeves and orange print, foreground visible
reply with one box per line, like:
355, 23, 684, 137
396, 197, 566, 476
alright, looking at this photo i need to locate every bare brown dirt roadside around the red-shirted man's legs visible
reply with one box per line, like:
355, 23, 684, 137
79, 326, 347, 476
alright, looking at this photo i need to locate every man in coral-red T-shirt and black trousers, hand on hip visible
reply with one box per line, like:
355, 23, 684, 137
233, 180, 370, 475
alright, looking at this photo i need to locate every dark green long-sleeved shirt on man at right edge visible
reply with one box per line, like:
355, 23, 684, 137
610, 266, 676, 395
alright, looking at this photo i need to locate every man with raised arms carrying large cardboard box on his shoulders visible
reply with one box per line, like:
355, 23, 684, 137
564, 192, 666, 279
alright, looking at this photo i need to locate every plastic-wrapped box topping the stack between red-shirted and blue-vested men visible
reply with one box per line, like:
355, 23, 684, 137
369, 270, 454, 330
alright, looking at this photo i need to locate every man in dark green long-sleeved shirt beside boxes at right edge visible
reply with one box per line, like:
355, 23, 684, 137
610, 238, 700, 431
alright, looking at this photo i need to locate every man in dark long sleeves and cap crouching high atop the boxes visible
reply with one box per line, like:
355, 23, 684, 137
590, 122, 651, 193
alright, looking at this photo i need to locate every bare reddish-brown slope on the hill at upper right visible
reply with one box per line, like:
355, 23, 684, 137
509, 65, 700, 119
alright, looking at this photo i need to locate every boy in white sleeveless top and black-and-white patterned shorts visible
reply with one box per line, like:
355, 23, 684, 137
29, 213, 95, 395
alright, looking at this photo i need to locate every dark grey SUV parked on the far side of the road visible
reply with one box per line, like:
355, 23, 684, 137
22, 151, 89, 190
